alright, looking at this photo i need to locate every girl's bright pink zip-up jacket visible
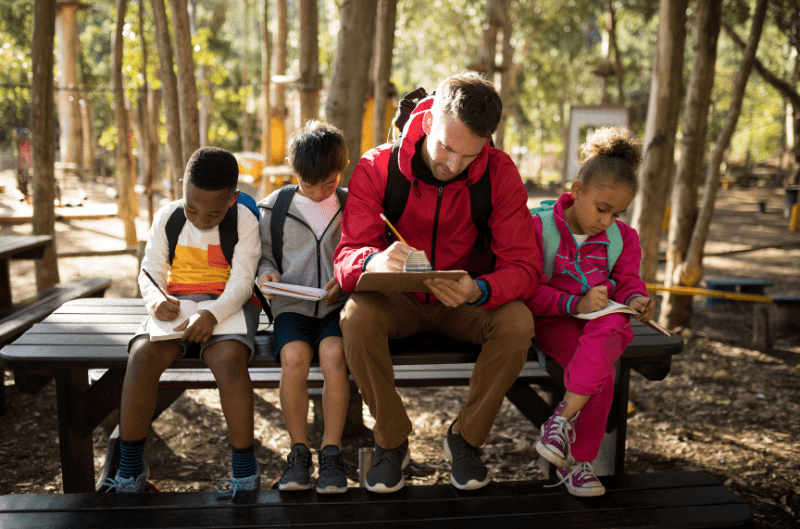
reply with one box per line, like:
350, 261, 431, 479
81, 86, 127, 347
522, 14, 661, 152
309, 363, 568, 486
526, 193, 648, 316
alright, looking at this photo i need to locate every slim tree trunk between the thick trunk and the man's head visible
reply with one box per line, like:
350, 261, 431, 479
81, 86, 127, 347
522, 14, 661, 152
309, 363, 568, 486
372, 0, 397, 145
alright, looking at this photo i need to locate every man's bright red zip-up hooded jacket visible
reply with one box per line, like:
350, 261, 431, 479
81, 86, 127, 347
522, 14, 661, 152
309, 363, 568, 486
334, 98, 541, 309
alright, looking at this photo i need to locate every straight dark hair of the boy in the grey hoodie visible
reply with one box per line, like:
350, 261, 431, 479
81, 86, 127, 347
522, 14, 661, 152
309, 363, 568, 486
287, 120, 348, 185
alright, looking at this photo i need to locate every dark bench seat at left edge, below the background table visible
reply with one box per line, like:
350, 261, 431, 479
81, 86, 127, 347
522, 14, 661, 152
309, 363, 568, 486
0, 277, 111, 416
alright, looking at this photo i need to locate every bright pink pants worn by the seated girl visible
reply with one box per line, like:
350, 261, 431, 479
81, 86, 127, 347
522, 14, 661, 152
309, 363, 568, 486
536, 314, 633, 461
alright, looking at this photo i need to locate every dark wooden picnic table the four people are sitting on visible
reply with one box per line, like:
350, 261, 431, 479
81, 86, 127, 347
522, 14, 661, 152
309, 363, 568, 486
0, 298, 683, 492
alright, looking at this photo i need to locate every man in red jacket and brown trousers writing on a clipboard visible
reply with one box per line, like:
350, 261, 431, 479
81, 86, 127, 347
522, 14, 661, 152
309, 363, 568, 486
334, 73, 540, 492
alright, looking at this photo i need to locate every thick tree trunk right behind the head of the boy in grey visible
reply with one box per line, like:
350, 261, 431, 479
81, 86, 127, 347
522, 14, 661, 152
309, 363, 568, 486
325, 0, 377, 187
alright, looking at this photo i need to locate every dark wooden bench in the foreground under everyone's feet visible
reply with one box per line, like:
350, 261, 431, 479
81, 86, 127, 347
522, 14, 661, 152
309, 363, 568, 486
0, 472, 753, 529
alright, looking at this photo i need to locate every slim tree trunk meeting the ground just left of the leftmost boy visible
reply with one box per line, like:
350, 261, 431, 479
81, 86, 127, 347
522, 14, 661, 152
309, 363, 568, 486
111, 0, 139, 248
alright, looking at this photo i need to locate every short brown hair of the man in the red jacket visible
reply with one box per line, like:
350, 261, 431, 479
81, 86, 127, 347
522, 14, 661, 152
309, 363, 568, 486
434, 72, 503, 138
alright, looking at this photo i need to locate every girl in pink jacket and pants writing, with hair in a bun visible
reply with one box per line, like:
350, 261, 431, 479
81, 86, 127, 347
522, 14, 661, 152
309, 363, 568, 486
527, 127, 655, 496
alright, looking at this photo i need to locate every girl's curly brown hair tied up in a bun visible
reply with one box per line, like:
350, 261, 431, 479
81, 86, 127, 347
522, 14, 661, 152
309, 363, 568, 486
576, 127, 642, 193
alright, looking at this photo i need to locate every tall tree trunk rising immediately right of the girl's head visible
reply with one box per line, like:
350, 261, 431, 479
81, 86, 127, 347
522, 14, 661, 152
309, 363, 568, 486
632, 0, 688, 283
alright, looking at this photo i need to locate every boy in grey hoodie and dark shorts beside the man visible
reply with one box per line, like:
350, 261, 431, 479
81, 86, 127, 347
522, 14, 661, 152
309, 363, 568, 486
258, 121, 350, 494
